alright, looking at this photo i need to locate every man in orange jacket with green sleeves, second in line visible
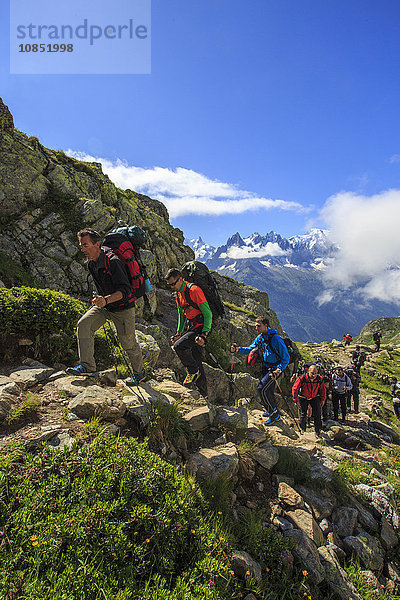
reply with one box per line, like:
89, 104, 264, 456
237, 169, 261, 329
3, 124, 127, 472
164, 269, 212, 396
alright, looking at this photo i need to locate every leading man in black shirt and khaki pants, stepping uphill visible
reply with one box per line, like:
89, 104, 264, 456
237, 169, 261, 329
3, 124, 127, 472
66, 229, 145, 385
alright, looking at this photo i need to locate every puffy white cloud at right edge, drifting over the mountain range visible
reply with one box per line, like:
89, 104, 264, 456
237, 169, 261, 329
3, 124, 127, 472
319, 190, 400, 303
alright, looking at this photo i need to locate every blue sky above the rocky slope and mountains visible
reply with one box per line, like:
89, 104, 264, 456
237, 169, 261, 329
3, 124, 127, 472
0, 0, 400, 245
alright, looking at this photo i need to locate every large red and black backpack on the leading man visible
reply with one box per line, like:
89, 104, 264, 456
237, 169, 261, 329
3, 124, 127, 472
103, 232, 147, 304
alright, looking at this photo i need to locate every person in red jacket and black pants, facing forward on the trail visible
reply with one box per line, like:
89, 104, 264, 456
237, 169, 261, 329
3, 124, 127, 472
292, 365, 326, 436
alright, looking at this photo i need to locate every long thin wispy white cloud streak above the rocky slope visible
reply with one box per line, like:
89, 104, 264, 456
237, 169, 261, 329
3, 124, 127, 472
66, 150, 309, 218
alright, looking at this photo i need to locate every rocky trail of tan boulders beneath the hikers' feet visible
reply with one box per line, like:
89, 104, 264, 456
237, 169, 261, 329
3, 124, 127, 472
0, 340, 400, 600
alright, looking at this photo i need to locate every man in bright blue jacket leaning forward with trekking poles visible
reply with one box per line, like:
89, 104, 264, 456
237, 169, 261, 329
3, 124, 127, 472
231, 317, 290, 425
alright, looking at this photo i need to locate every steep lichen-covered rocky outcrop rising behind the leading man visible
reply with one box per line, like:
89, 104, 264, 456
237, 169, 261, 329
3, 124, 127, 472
0, 101, 194, 295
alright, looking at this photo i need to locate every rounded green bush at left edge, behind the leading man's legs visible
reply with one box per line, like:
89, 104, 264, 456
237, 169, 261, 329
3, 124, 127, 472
0, 287, 84, 361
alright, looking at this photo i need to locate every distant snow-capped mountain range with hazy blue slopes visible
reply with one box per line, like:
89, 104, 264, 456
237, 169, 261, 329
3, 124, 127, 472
186, 229, 399, 342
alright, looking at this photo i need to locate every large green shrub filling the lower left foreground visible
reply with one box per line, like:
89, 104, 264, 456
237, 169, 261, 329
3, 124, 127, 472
0, 427, 233, 600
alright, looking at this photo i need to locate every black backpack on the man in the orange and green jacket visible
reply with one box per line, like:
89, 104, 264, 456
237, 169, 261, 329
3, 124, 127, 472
181, 260, 225, 321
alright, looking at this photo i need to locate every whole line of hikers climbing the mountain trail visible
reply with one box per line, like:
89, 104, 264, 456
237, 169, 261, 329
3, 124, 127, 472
67, 228, 394, 436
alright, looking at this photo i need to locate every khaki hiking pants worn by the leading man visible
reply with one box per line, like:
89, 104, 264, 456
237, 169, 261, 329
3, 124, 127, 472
76, 306, 143, 373
